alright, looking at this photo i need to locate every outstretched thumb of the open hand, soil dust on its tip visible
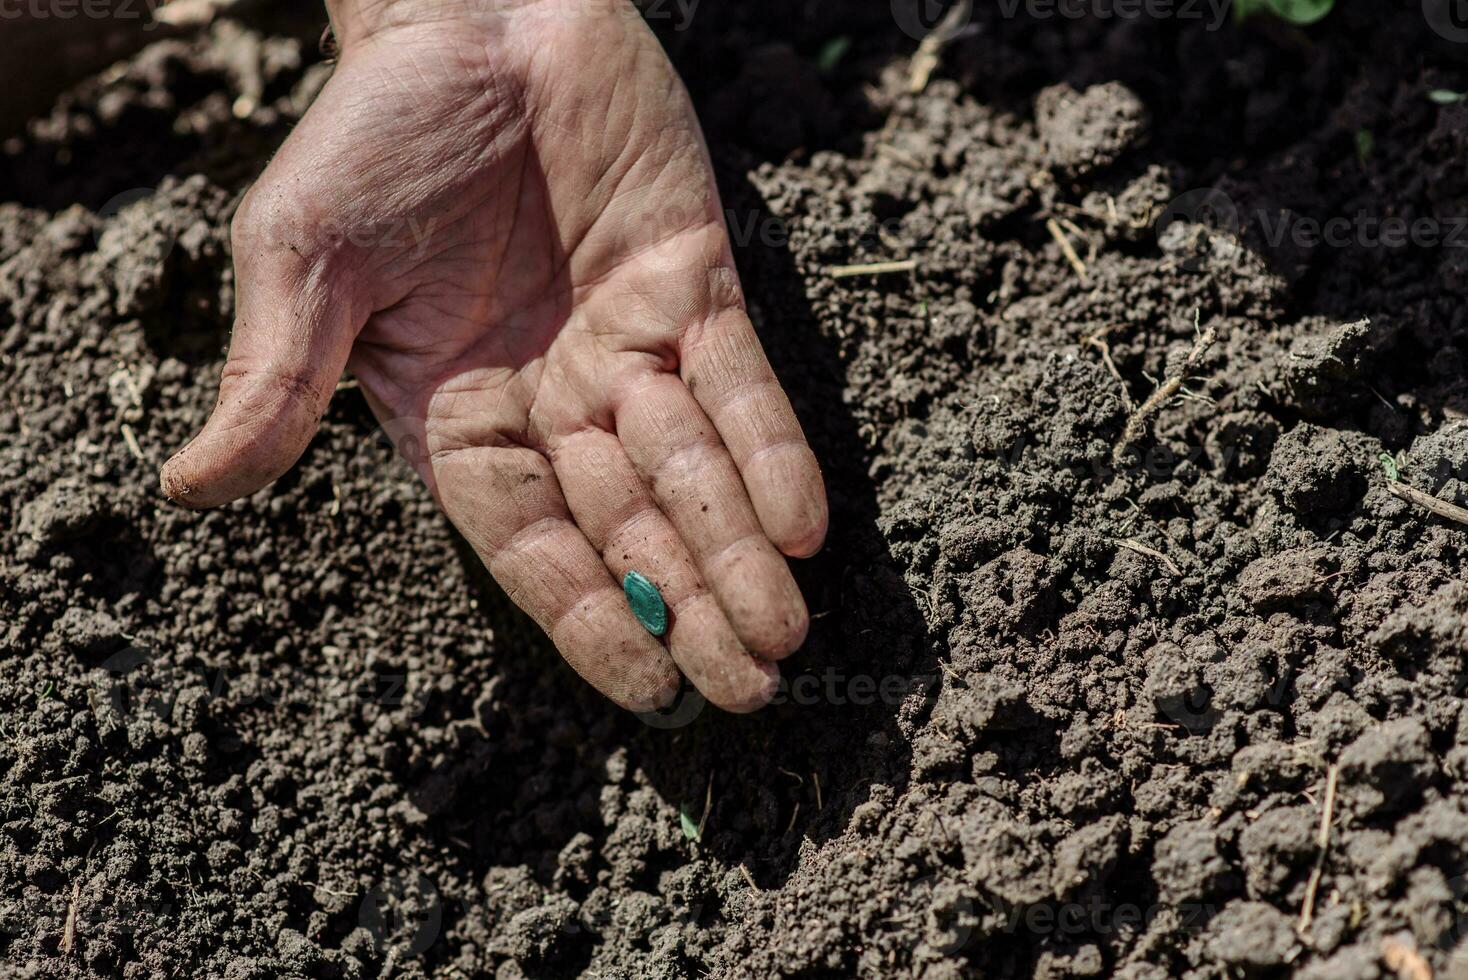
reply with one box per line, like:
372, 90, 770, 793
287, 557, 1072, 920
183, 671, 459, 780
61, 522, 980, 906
160, 195, 360, 509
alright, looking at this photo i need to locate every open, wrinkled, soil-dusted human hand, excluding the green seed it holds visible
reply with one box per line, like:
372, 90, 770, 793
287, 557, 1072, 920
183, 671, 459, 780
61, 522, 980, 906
163, 0, 826, 710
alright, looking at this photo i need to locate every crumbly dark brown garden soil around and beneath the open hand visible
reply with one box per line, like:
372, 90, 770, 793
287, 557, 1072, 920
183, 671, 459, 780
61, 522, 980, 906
0, 0, 1468, 980
